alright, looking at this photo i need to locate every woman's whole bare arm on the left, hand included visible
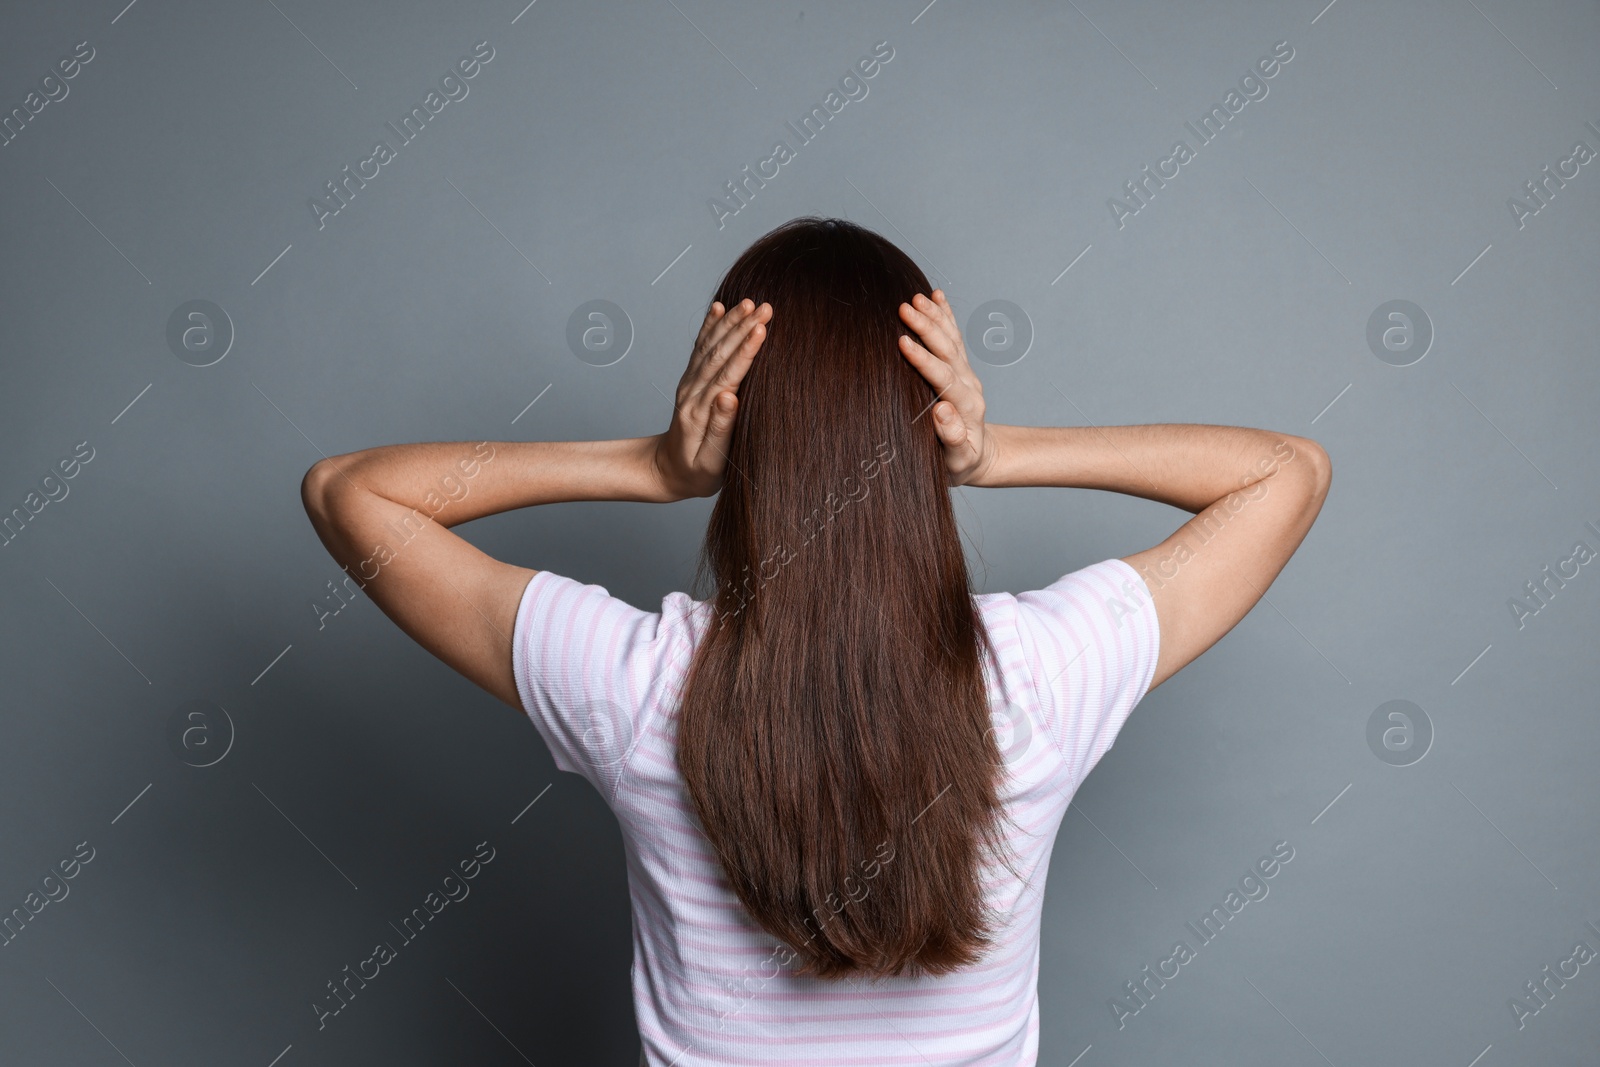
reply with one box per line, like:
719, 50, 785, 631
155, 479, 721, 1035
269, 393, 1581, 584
301, 295, 771, 710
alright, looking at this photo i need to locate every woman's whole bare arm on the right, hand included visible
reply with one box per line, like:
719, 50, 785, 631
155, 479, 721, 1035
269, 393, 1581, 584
901, 290, 1333, 689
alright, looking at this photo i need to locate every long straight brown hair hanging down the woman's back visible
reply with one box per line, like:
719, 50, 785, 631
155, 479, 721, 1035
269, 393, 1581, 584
678, 218, 1003, 977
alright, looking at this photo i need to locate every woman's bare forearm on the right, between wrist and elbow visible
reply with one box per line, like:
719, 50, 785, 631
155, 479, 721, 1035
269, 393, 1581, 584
971, 424, 1315, 514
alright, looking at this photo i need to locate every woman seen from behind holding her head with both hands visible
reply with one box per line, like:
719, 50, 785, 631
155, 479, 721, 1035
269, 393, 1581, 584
302, 212, 1330, 1067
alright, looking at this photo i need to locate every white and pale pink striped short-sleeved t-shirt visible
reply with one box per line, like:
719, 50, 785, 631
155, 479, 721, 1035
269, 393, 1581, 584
512, 558, 1160, 1067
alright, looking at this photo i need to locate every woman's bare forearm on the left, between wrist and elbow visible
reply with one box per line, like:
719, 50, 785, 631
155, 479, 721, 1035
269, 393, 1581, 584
308, 437, 672, 526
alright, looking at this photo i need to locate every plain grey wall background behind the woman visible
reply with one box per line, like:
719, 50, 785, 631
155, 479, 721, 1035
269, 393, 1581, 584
0, 0, 1600, 1067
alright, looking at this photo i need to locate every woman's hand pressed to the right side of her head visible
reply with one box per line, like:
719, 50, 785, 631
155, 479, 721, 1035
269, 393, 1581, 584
899, 290, 995, 485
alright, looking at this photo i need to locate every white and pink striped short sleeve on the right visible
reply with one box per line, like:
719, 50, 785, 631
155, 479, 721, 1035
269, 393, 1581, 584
1016, 558, 1162, 785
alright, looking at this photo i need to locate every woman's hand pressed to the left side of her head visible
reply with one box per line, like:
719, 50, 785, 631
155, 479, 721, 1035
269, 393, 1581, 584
654, 299, 773, 499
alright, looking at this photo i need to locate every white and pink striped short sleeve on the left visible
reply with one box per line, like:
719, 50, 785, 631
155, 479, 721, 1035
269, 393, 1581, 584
512, 571, 694, 801
